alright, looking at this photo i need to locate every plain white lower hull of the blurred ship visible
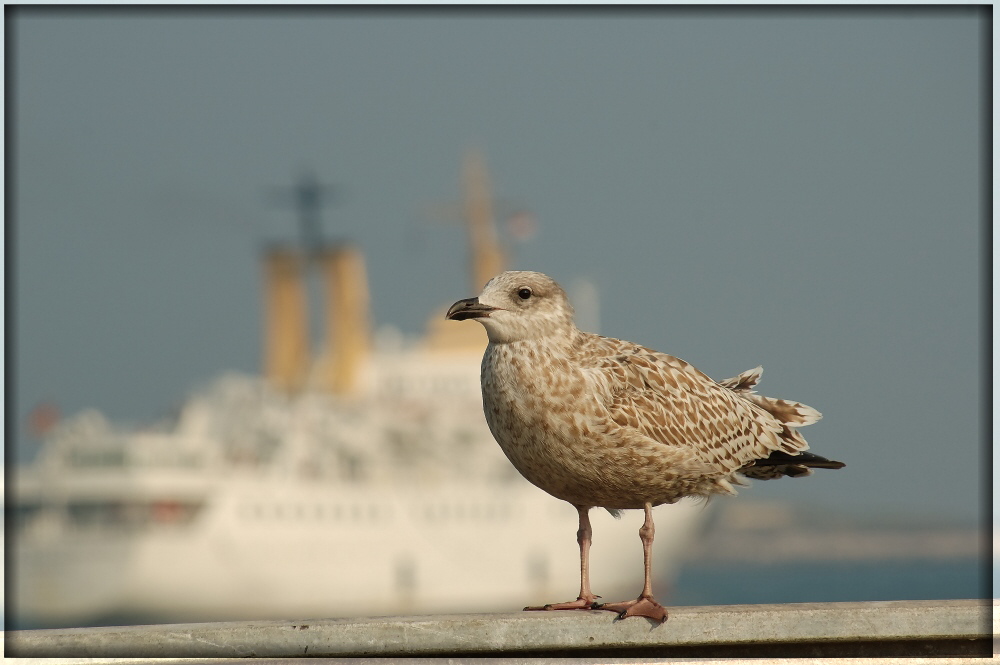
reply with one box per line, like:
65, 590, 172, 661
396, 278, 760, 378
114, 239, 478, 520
15, 470, 702, 625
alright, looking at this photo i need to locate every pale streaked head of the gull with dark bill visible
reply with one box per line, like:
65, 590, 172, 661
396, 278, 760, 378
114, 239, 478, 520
447, 271, 576, 344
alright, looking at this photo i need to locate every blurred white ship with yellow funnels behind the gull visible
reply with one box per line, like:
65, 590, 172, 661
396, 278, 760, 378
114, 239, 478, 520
8, 154, 702, 626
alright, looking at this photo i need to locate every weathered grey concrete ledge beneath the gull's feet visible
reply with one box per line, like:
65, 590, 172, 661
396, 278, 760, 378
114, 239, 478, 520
4, 600, 993, 658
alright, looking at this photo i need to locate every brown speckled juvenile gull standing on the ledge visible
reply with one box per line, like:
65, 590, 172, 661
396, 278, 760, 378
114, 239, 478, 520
447, 272, 844, 621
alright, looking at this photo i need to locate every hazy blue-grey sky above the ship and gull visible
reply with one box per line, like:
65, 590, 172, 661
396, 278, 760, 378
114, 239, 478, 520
7, 7, 988, 520
